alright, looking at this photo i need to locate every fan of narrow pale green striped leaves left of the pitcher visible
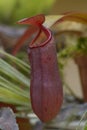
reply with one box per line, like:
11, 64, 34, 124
0, 50, 31, 111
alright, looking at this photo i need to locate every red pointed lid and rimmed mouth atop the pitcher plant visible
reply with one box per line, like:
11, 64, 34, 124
17, 14, 52, 48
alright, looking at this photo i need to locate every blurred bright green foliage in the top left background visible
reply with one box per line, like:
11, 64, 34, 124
0, 0, 55, 24
